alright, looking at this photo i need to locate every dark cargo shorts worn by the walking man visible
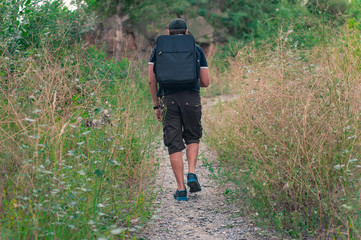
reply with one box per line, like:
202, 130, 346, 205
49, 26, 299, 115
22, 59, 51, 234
162, 90, 202, 154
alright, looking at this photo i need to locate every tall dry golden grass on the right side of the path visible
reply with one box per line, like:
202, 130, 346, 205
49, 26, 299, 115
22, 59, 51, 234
207, 30, 361, 239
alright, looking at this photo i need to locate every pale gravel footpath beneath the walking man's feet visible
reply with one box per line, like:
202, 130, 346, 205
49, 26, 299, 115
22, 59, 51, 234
141, 97, 280, 240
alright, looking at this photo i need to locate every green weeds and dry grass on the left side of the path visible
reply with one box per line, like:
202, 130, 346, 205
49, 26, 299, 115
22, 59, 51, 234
0, 45, 155, 239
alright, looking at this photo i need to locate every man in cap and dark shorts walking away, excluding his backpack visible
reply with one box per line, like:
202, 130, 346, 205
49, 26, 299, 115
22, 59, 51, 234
148, 18, 209, 201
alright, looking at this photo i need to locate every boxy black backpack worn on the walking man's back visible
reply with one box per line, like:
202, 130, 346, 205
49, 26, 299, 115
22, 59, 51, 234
154, 35, 199, 89
